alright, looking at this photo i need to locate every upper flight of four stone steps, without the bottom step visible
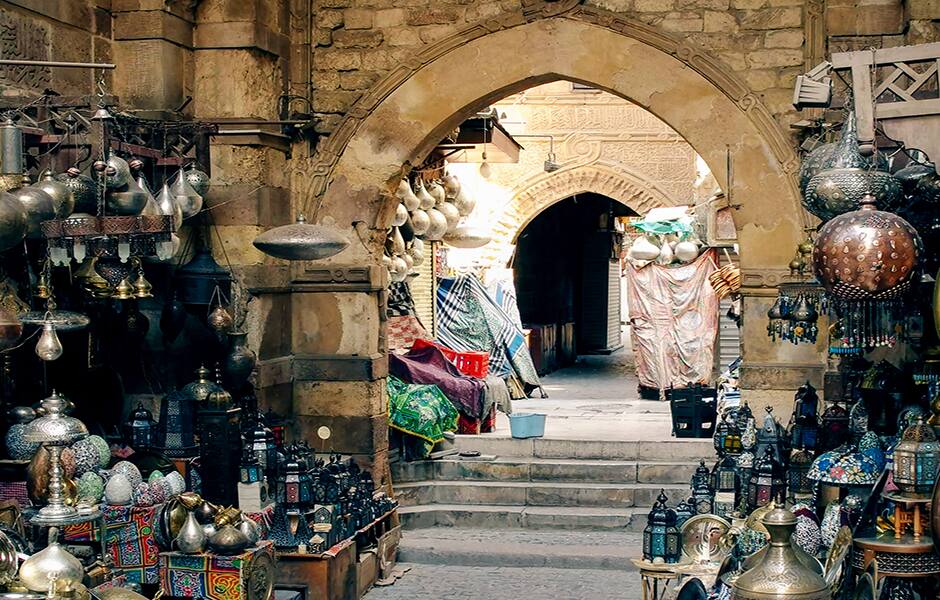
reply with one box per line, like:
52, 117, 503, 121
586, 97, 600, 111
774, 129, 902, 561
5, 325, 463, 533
392, 436, 714, 532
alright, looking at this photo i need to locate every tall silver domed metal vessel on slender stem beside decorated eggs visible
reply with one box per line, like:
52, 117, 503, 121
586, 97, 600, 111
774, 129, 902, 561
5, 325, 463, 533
23, 391, 88, 524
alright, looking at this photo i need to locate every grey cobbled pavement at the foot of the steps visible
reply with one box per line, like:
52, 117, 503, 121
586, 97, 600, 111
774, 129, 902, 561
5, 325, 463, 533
365, 564, 641, 600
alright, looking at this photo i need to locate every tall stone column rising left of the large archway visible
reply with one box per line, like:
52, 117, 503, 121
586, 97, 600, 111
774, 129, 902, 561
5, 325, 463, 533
192, 0, 293, 418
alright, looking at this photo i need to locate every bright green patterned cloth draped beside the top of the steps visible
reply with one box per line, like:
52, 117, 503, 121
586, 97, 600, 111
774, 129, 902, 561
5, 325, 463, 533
387, 375, 457, 444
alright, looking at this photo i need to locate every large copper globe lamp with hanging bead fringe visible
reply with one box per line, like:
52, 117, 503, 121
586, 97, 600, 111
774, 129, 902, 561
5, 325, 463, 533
813, 194, 923, 348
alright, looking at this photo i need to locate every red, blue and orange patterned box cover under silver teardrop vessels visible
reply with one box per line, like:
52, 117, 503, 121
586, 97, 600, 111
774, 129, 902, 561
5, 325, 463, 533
160, 541, 274, 600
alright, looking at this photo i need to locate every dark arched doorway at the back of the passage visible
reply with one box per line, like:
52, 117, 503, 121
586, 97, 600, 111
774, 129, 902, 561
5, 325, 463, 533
513, 193, 636, 373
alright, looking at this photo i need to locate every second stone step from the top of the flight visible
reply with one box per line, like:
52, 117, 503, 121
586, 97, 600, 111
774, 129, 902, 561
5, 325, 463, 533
392, 456, 698, 484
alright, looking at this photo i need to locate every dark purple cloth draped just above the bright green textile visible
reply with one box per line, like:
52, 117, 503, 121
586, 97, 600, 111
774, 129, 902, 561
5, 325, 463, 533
388, 346, 484, 419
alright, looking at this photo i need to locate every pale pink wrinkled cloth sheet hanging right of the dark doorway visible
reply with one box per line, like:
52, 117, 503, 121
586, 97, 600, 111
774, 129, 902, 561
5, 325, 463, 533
627, 250, 718, 389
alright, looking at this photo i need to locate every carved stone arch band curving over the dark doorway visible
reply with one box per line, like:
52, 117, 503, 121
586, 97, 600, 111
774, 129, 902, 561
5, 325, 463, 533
481, 163, 677, 265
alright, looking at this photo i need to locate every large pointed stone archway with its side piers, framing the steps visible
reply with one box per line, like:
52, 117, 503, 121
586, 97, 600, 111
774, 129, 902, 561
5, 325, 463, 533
291, 0, 824, 473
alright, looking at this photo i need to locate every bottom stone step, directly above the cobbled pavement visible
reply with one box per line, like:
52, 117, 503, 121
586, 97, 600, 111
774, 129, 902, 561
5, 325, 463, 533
398, 527, 643, 571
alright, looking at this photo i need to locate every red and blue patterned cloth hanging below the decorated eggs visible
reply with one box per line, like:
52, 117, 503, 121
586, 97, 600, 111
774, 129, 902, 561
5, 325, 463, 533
65, 504, 163, 583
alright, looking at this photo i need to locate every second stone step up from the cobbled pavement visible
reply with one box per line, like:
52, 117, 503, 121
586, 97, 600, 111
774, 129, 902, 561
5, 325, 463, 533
398, 503, 649, 538
